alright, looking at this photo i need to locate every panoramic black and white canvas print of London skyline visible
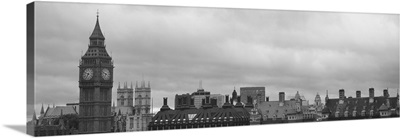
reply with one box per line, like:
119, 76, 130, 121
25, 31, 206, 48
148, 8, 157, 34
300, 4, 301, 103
21, 2, 400, 136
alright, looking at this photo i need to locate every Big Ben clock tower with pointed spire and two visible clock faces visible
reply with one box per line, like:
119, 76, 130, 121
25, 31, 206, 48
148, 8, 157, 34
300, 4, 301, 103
79, 15, 114, 133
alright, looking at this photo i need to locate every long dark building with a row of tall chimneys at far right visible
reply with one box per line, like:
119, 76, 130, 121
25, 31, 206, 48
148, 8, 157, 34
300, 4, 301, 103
322, 88, 399, 120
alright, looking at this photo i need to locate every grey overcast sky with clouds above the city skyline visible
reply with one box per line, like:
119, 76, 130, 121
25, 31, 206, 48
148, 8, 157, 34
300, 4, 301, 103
28, 2, 399, 116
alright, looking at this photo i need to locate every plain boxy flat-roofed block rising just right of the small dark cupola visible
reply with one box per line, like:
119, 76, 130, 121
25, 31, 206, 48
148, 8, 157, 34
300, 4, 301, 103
240, 87, 265, 103
